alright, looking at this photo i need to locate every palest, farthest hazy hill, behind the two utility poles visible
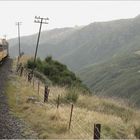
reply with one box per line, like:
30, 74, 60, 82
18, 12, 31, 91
9, 28, 78, 63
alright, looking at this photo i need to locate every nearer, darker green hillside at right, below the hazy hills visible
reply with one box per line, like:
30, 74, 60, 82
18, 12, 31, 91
80, 52, 140, 106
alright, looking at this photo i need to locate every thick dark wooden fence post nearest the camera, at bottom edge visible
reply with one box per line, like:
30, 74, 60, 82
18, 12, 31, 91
93, 124, 101, 140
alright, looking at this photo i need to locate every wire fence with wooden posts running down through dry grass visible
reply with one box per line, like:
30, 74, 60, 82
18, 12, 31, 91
15, 66, 100, 139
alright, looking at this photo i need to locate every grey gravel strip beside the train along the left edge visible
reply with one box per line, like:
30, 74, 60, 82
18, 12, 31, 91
0, 59, 36, 139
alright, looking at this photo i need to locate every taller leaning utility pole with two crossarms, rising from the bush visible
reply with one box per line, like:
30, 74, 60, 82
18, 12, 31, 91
33, 16, 49, 66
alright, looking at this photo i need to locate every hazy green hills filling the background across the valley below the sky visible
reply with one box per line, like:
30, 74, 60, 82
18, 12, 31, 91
9, 16, 140, 107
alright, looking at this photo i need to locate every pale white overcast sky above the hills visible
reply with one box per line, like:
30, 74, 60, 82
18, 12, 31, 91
0, 1, 140, 39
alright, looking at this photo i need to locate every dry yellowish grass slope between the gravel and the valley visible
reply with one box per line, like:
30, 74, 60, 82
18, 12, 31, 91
6, 59, 140, 138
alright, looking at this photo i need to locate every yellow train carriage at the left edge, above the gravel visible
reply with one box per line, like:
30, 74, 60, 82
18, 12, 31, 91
0, 38, 9, 62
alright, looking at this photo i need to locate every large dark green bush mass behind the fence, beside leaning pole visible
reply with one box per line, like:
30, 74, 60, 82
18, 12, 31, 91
27, 56, 84, 87
